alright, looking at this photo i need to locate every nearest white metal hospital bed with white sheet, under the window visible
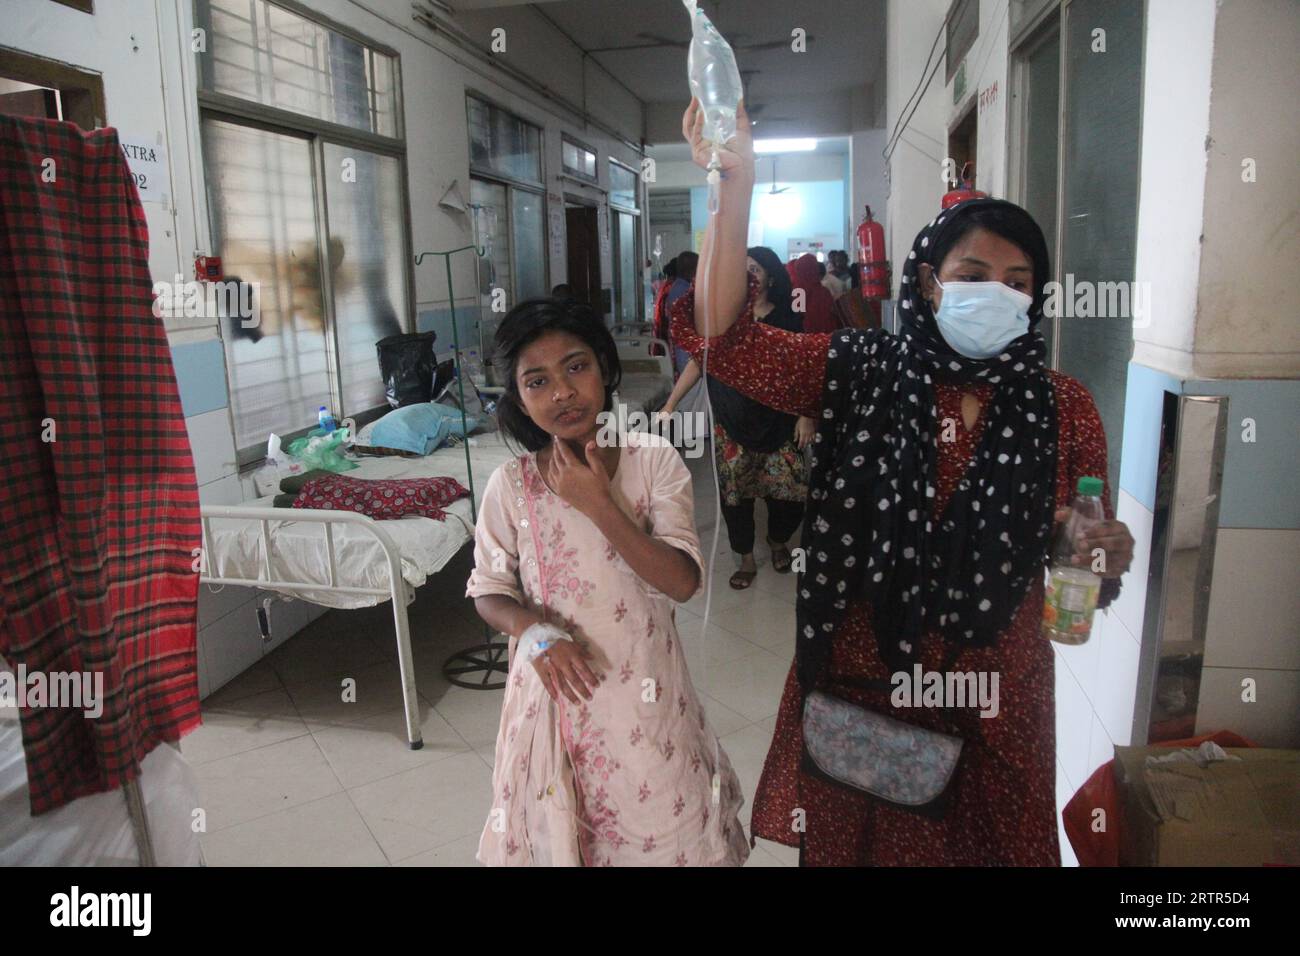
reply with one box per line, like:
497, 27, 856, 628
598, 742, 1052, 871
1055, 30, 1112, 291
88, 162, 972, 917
199, 429, 512, 749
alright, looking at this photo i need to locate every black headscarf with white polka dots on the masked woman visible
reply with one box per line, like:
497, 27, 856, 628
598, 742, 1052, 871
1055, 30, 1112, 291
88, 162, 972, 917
796, 199, 1057, 688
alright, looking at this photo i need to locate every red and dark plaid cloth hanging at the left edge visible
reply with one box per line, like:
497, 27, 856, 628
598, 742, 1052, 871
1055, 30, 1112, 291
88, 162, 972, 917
0, 116, 200, 814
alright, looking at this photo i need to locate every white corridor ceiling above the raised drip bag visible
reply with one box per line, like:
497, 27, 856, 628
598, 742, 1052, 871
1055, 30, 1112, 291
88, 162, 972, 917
445, 0, 885, 140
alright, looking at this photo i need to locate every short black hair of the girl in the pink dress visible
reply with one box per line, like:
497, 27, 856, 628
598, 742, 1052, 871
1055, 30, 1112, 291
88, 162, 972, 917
493, 299, 623, 451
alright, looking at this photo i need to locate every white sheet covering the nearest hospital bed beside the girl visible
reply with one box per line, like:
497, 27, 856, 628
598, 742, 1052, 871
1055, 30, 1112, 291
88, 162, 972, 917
207, 432, 512, 609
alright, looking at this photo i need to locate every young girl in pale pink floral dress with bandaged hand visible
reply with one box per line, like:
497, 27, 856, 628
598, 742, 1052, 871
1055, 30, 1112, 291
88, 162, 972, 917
467, 293, 749, 866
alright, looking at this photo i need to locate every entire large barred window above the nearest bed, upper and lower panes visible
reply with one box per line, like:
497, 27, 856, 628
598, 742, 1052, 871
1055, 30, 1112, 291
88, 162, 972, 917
196, 0, 412, 464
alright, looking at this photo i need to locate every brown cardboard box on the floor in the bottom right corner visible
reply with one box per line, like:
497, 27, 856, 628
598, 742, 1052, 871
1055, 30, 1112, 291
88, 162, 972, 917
1115, 747, 1300, 866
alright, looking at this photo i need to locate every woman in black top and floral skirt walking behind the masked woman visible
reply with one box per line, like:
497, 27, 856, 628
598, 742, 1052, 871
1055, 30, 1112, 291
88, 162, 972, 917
659, 246, 816, 591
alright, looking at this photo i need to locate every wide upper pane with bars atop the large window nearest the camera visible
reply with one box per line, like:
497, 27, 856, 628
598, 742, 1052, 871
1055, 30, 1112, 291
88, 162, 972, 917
204, 0, 398, 137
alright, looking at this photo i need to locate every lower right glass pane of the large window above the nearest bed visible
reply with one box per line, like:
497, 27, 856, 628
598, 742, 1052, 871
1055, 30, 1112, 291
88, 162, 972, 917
325, 143, 410, 415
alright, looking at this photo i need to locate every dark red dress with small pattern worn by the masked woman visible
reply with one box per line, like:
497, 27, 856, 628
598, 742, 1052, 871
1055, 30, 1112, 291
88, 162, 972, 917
673, 286, 1114, 866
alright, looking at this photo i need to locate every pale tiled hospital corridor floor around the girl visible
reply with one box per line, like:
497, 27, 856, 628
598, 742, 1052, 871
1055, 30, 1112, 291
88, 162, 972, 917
182, 458, 798, 866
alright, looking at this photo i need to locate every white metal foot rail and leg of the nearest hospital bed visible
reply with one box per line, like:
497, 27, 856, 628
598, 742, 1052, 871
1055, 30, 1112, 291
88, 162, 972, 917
199, 505, 424, 750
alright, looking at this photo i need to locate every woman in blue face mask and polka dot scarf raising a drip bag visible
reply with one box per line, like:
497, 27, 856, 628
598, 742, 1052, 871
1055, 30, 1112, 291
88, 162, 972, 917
673, 103, 1132, 866
